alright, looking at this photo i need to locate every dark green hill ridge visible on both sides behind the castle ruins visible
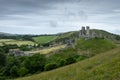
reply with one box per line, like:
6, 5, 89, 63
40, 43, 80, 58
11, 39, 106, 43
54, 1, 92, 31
54, 29, 120, 43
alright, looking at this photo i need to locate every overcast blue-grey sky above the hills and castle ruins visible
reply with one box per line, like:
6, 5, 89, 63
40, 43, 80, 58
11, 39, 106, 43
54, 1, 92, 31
0, 0, 120, 34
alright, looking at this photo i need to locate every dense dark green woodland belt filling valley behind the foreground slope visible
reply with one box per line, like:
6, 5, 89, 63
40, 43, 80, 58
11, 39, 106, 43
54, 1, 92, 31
0, 45, 86, 79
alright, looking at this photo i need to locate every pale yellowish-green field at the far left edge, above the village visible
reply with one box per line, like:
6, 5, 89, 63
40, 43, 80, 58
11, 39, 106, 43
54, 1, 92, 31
0, 39, 34, 46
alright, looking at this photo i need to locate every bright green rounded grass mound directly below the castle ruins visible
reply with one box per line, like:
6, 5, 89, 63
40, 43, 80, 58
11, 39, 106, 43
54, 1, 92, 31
76, 39, 116, 56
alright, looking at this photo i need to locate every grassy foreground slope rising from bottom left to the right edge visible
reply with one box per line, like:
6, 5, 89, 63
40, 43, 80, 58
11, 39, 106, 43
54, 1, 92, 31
15, 47, 120, 80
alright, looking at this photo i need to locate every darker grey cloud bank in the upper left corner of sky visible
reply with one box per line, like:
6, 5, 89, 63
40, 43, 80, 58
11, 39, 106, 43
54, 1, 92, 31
0, 0, 81, 19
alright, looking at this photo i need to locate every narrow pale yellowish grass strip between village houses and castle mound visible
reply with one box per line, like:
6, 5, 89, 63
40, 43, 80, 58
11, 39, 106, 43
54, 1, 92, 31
26, 45, 65, 54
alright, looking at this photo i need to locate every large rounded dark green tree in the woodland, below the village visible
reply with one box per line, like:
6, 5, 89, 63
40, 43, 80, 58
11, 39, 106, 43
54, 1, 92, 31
23, 54, 46, 73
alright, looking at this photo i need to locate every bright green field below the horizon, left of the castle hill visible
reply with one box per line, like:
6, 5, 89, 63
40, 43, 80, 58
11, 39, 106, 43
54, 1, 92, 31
33, 36, 58, 44
